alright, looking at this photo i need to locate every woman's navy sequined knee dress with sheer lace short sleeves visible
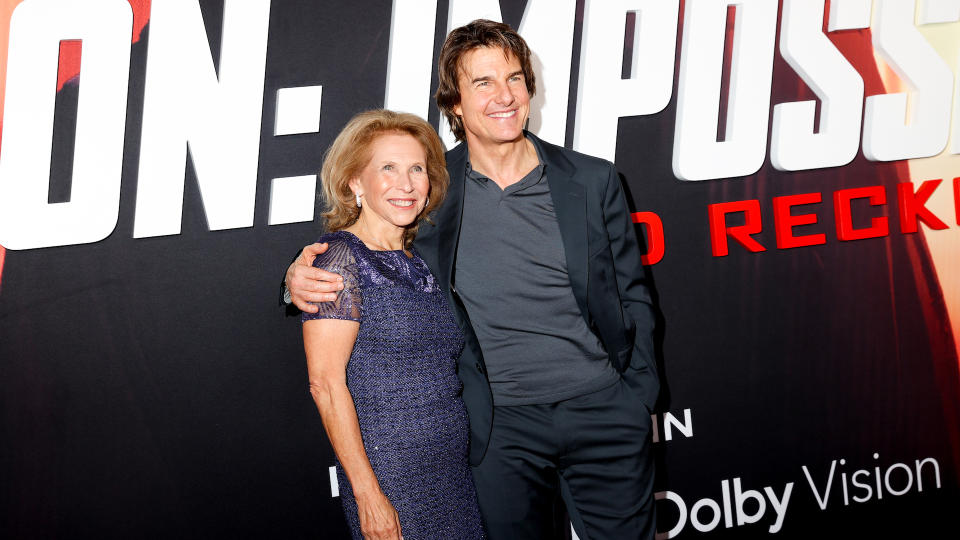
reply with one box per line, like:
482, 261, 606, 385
302, 231, 483, 540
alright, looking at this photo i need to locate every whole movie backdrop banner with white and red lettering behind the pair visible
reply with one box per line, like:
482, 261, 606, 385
0, 0, 960, 539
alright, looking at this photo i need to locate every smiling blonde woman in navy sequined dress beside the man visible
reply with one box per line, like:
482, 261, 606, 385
302, 110, 483, 540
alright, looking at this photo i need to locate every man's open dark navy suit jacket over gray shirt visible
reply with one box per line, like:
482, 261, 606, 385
414, 133, 660, 465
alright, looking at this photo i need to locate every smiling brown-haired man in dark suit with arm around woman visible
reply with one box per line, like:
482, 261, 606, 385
287, 20, 659, 540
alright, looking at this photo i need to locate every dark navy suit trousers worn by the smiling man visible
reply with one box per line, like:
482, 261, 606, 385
473, 381, 656, 540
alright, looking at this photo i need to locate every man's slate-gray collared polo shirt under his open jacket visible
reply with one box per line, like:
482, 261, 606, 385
454, 139, 619, 406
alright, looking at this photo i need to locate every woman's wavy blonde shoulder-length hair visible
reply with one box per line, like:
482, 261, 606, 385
320, 109, 450, 247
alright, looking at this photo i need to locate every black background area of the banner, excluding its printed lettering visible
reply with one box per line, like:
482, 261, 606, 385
0, 0, 960, 538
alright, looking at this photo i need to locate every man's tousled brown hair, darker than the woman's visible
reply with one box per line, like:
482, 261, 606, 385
435, 19, 537, 141
